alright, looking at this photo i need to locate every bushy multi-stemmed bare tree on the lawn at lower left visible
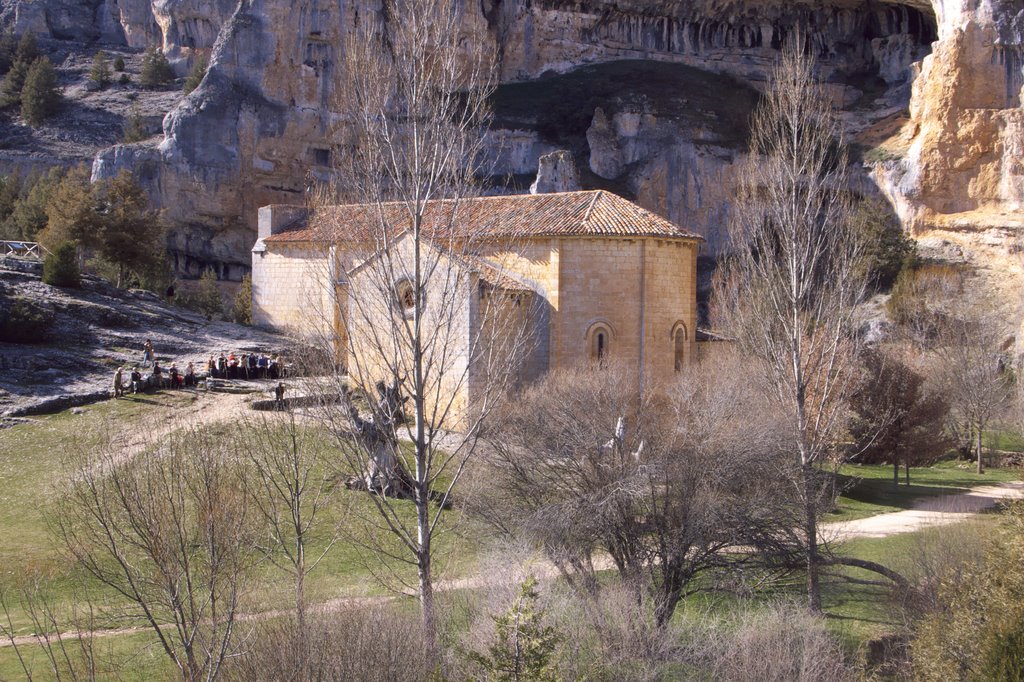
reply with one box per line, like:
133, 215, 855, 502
53, 429, 256, 681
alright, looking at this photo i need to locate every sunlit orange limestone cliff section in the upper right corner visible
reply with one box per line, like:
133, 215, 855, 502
876, 0, 1024, 233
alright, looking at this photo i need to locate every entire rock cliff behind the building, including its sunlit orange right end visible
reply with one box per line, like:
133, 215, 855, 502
0, 0, 1024, 279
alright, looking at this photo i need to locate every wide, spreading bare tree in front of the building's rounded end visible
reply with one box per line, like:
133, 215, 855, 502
473, 358, 788, 627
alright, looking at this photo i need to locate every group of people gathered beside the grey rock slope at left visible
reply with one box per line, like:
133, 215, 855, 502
114, 339, 285, 401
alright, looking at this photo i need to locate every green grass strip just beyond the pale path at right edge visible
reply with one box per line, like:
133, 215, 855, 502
822, 462, 1022, 522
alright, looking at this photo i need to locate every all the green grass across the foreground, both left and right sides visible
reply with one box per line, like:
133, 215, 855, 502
0, 392, 1020, 680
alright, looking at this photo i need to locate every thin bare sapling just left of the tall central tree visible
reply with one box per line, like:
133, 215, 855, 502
230, 412, 339, 667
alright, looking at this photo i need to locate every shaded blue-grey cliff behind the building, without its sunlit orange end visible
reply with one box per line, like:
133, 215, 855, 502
94, 0, 936, 275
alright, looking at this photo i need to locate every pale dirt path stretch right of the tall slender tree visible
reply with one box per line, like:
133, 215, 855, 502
821, 481, 1024, 541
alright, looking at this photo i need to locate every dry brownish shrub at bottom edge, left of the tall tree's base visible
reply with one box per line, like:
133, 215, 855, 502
226, 604, 436, 682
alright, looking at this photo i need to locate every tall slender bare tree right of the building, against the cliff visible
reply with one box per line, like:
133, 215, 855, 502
715, 36, 865, 611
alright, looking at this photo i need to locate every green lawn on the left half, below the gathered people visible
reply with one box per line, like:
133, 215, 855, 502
0, 391, 479, 634
